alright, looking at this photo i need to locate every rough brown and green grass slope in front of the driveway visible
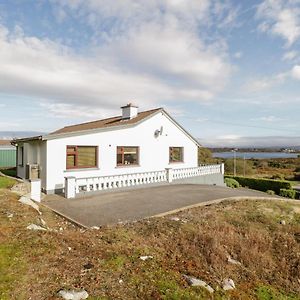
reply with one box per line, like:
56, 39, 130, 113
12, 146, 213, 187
0, 190, 300, 300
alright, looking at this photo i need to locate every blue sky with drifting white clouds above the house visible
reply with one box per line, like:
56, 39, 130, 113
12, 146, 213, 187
0, 0, 300, 145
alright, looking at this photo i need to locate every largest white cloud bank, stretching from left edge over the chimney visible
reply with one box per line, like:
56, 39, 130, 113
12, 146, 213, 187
0, 0, 232, 117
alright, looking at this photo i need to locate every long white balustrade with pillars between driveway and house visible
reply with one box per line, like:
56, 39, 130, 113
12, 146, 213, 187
65, 165, 224, 198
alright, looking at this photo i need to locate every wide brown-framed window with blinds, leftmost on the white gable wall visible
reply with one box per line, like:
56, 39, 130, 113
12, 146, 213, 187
67, 146, 98, 169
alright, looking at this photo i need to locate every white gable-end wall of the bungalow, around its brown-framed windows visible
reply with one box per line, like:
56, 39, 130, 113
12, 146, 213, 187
46, 112, 198, 192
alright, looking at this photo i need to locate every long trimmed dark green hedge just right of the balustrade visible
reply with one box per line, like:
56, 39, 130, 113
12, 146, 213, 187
226, 176, 292, 194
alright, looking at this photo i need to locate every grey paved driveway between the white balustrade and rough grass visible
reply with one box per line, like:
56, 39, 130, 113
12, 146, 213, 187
43, 184, 278, 227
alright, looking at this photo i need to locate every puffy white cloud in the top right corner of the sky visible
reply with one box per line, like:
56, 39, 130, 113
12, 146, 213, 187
256, 0, 300, 47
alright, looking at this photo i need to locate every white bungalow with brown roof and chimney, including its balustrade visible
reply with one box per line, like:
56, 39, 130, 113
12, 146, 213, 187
13, 104, 223, 198
